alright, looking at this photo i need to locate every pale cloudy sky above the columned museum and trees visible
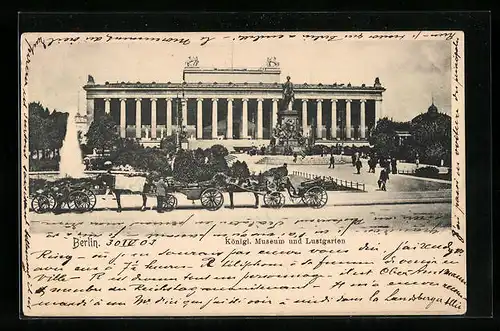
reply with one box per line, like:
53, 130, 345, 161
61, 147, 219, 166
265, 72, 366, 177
22, 33, 451, 121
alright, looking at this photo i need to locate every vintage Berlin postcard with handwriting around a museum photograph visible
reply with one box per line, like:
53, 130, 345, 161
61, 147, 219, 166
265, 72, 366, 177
20, 31, 467, 317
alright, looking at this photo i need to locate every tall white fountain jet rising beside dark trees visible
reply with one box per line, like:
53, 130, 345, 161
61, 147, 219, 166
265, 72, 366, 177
59, 114, 85, 178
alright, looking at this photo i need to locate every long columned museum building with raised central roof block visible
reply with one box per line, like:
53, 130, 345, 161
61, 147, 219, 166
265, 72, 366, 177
80, 59, 385, 148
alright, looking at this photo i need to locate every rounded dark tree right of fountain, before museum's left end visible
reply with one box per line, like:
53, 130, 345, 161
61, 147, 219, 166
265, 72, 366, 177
86, 114, 120, 155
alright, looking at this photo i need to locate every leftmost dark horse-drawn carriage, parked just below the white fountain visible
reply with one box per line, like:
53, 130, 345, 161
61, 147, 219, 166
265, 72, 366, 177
31, 180, 97, 213
